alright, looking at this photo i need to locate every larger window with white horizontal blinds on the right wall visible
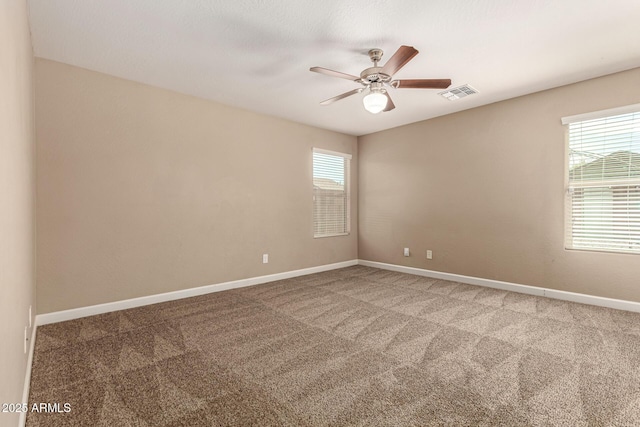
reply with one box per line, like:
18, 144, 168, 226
562, 104, 640, 254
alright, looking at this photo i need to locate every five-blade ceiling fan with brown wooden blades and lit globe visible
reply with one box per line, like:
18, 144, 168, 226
309, 46, 451, 114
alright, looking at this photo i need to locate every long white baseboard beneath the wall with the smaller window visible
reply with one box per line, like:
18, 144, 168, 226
36, 260, 358, 325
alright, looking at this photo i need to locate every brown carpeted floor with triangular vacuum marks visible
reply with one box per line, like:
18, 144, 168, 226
27, 266, 640, 427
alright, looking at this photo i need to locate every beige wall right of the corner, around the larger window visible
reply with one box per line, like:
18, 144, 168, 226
358, 69, 640, 301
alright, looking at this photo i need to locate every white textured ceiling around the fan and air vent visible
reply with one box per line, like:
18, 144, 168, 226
29, 0, 640, 135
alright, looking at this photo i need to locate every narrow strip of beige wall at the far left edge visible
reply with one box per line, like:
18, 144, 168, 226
0, 0, 35, 426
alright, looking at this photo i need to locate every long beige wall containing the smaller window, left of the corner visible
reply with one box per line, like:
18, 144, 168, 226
35, 59, 357, 313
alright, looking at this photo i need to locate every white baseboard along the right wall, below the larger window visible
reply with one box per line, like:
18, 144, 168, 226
358, 259, 640, 313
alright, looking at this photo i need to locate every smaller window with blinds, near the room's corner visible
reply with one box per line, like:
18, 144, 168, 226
313, 148, 351, 237
